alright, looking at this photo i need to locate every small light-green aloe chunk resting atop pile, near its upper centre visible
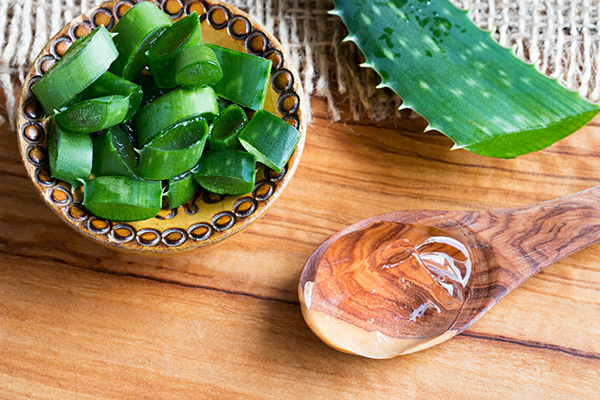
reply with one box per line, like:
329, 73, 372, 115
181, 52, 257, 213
174, 45, 223, 87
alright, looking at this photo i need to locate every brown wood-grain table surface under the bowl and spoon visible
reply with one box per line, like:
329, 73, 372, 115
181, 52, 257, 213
0, 85, 600, 400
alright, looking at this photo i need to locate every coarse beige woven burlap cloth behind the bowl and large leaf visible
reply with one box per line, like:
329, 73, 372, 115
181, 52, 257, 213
0, 0, 600, 126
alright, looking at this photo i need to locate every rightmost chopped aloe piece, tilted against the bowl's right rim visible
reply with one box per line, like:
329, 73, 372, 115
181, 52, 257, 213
239, 110, 300, 172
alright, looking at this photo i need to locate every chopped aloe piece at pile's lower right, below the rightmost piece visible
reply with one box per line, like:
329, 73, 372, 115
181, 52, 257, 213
194, 149, 256, 196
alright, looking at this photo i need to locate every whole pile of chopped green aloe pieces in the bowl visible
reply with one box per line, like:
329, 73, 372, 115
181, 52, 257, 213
42, 7, 300, 222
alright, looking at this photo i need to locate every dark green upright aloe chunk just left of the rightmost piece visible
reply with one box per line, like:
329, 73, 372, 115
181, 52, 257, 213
208, 104, 248, 150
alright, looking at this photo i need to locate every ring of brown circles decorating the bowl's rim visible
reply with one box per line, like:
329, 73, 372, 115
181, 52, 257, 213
19, 0, 308, 253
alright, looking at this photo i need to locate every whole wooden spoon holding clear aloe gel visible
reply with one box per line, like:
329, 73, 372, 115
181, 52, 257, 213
299, 186, 600, 358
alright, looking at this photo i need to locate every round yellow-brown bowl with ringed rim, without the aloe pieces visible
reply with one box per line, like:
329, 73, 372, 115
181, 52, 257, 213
17, 0, 307, 255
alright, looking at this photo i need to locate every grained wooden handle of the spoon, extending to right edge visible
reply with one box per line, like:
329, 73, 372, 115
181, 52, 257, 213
469, 186, 600, 291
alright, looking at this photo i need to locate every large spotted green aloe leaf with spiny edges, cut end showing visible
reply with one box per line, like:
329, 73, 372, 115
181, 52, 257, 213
331, 0, 600, 158
